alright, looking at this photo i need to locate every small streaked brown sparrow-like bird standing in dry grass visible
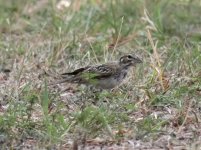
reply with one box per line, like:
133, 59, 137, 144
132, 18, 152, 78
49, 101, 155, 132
56, 54, 142, 89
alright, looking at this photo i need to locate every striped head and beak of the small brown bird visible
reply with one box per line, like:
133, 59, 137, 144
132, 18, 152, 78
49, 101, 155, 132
119, 54, 142, 67
